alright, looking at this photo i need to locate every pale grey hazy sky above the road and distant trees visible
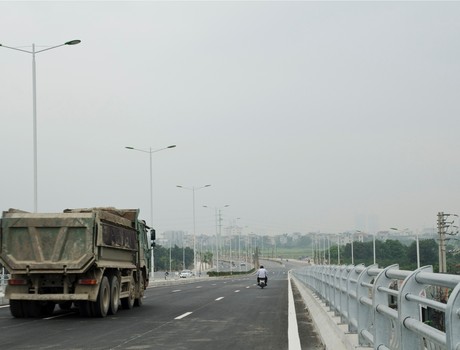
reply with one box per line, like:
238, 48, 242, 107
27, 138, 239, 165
0, 1, 460, 234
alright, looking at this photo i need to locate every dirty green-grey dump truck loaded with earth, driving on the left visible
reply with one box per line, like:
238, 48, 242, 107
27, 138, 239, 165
0, 207, 155, 318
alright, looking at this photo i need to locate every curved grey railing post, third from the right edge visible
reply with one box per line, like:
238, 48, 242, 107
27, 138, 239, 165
372, 264, 398, 349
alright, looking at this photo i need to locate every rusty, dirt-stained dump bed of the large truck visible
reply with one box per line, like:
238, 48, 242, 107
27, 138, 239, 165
0, 208, 139, 274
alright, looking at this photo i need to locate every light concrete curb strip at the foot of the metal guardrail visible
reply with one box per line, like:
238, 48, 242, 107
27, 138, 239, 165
291, 274, 372, 350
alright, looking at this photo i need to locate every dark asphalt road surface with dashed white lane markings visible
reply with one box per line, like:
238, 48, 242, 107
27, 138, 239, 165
0, 263, 322, 350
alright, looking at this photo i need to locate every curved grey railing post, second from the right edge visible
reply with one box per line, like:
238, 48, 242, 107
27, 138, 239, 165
398, 266, 434, 350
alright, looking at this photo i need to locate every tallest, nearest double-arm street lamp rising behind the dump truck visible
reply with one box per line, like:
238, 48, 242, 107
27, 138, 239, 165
0, 40, 81, 213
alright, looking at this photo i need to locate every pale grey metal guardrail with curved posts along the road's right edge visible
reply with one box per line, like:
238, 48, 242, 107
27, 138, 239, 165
293, 265, 460, 350
